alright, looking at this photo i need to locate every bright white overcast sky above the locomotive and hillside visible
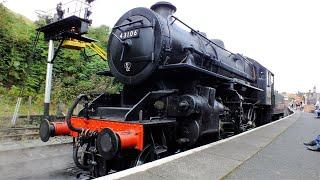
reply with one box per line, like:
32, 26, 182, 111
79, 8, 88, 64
0, 0, 320, 92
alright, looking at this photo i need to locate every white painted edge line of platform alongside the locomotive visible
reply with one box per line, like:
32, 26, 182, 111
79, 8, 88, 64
97, 109, 295, 180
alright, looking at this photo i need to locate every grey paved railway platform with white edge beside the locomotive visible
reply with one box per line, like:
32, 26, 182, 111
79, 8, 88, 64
99, 111, 320, 180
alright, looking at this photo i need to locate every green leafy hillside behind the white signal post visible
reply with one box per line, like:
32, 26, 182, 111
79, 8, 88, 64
0, 4, 120, 115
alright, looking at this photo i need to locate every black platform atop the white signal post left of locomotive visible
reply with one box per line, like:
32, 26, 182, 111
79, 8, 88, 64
37, 16, 91, 41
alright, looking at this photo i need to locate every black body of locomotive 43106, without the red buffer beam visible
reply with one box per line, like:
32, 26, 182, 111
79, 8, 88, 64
108, 2, 274, 146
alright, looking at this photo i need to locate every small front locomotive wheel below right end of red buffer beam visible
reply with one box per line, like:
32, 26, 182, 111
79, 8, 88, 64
133, 144, 166, 166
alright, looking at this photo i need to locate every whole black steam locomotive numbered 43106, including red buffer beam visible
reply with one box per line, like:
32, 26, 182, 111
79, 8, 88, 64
42, 2, 274, 176
